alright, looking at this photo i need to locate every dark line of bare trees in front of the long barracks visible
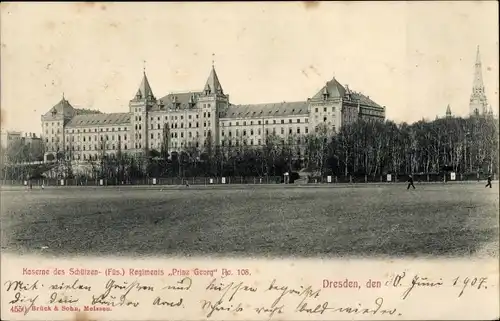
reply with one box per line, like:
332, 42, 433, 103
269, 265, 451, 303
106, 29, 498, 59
1, 116, 499, 180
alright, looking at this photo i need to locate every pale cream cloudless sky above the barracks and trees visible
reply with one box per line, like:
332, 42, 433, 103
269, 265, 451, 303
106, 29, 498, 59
0, 1, 499, 133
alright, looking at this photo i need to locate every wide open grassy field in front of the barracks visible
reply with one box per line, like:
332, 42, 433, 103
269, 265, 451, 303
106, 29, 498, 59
1, 183, 499, 258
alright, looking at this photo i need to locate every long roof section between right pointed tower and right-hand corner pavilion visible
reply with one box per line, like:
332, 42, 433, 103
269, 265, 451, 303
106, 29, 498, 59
222, 101, 308, 118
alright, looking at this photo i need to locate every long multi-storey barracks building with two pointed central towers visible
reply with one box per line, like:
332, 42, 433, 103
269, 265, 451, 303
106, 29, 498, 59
41, 66, 385, 161
